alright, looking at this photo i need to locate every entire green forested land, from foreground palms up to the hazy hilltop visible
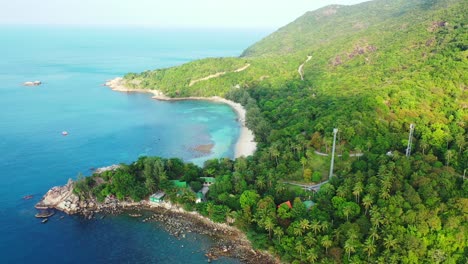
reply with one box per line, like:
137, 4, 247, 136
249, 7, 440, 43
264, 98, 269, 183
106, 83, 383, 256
89, 0, 468, 263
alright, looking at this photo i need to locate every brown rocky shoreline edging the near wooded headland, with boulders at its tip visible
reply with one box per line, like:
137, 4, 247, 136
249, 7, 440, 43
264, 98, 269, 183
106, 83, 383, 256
35, 179, 279, 264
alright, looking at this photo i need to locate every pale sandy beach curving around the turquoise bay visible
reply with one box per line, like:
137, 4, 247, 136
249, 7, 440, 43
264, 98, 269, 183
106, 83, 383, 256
105, 77, 257, 158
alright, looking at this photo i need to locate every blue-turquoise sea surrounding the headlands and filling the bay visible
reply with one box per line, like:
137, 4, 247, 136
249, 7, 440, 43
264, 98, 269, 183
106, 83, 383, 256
0, 26, 267, 263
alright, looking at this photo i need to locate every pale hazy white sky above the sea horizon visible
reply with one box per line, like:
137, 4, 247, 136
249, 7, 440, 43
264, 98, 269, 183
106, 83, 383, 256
0, 0, 365, 28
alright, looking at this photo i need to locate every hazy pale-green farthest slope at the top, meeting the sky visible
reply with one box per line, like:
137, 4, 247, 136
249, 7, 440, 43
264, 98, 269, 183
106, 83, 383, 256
241, 0, 466, 57
